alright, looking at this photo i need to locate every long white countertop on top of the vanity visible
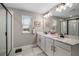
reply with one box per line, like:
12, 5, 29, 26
37, 32, 79, 45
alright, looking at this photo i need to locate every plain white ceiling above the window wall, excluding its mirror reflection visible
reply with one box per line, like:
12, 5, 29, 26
4, 3, 58, 14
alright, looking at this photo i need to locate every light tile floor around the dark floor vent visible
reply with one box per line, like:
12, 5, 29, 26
10, 45, 46, 56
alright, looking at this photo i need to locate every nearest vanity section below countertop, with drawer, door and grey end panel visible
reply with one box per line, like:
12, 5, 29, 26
54, 41, 79, 56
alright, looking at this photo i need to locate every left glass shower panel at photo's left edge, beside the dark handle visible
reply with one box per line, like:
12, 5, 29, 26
0, 4, 6, 56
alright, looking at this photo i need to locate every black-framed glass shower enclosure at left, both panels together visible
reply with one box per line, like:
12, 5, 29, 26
0, 3, 12, 56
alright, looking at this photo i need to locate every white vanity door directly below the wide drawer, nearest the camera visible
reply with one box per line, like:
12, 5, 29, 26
54, 46, 71, 56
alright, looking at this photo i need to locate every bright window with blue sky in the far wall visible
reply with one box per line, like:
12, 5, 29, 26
22, 16, 31, 33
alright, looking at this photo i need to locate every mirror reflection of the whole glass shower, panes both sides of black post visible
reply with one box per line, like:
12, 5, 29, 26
61, 19, 79, 36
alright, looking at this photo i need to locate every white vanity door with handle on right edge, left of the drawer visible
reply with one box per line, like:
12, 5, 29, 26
45, 38, 53, 56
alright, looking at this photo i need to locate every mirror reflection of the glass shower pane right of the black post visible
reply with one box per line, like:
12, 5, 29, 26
68, 20, 79, 36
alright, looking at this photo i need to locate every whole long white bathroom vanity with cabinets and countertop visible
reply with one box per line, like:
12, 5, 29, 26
37, 32, 79, 56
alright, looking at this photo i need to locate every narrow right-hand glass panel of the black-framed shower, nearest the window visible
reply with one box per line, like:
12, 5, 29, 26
7, 12, 12, 55
